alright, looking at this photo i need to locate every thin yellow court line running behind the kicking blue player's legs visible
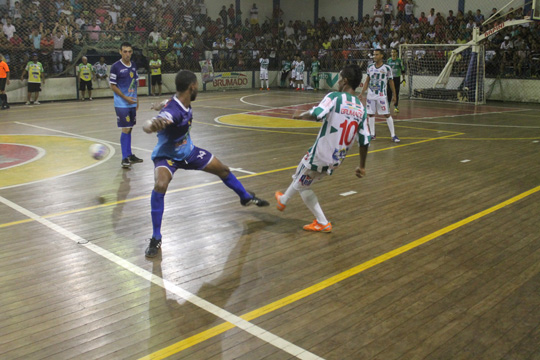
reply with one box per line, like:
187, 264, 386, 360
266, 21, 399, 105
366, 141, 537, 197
0, 133, 462, 229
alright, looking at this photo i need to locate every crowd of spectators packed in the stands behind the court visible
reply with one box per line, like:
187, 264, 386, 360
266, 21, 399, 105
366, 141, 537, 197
0, 0, 540, 77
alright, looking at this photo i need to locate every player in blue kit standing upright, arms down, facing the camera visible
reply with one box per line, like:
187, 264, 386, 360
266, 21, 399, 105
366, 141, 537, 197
109, 42, 143, 169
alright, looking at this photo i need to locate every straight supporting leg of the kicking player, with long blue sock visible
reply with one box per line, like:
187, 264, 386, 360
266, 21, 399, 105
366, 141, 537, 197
144, 159, 176, 257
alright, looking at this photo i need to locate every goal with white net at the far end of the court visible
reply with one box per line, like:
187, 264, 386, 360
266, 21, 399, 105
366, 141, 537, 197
399, 44, 485, 104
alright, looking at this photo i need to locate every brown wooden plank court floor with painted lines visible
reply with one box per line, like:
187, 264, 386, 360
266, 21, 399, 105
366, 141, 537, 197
0, 91, 540, 360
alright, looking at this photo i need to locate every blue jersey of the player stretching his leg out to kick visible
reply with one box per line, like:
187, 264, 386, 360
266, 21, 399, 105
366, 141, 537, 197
152, 96, 194, 161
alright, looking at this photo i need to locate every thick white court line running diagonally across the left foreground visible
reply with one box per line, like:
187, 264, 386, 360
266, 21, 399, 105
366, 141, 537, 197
0, 196, 323, 360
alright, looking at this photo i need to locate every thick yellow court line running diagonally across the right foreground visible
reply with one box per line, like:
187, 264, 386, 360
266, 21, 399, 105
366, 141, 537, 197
140, 186, 540, 360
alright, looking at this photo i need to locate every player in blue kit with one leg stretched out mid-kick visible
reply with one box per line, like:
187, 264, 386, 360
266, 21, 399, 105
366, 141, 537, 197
143, 70, 269, 257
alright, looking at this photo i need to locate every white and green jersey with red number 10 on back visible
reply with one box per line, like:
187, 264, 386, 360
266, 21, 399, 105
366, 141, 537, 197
303, 91, 370, 174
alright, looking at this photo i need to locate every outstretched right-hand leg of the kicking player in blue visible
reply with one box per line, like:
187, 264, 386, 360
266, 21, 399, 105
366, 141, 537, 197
190, 147, 269, 206
